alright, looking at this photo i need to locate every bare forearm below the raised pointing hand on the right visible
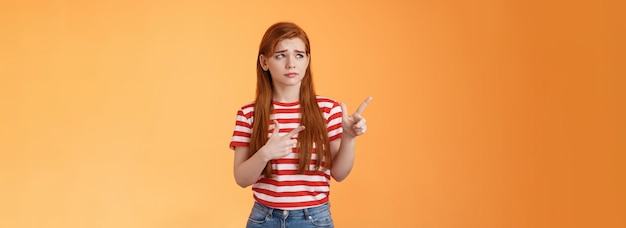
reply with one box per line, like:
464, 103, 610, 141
331, 135, 356, 181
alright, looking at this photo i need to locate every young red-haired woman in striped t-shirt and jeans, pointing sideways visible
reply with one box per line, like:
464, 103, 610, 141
230, 22, 371, 227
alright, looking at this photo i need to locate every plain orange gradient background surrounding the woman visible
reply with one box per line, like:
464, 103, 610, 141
0, 0, 626, 228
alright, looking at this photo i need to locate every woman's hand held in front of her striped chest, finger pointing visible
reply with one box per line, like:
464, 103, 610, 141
259, 120, 304, 162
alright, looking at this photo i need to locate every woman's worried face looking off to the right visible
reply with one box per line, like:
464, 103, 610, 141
260, 38, 309, 88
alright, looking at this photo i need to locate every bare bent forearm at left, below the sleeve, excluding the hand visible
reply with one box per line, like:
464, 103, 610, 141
234, 151, 268, 188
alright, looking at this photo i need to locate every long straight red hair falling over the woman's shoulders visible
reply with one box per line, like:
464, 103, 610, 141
250, 22, 332, 178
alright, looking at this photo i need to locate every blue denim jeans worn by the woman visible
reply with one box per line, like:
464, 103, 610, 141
246, 202, 335, 228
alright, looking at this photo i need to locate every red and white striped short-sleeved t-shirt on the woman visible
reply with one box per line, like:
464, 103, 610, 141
230, 96, 342, 209
